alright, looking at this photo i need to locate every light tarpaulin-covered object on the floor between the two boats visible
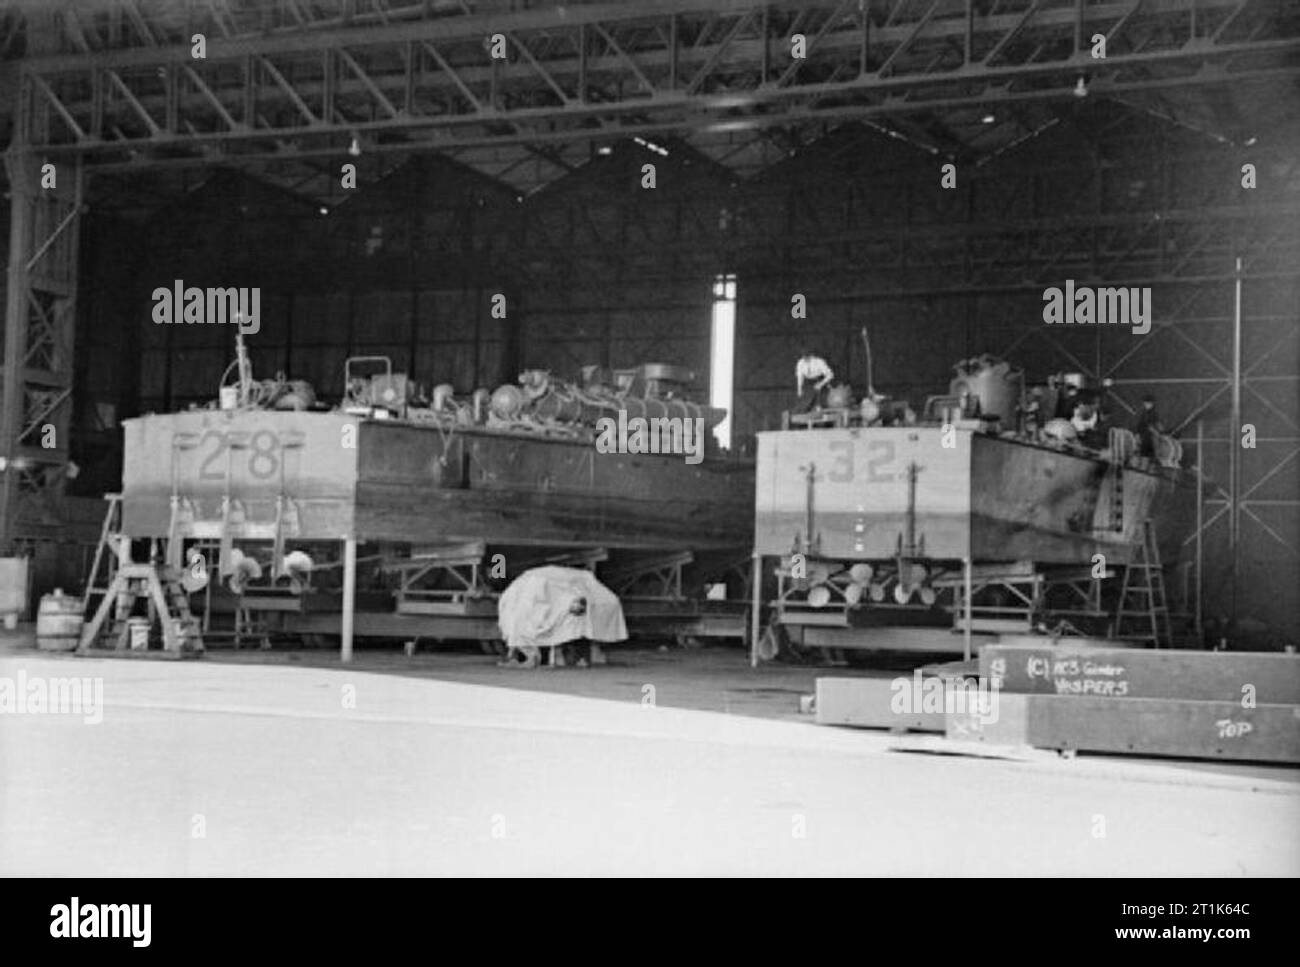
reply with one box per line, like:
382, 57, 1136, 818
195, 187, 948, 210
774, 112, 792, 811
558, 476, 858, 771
497, 567, 628, 668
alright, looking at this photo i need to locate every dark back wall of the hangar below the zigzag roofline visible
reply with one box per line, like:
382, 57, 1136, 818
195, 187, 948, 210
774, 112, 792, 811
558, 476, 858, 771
78, 113, 1300, 642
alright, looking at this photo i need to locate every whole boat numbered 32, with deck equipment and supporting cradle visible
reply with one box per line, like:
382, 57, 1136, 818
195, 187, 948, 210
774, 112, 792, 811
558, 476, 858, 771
751, 356, 1195, 660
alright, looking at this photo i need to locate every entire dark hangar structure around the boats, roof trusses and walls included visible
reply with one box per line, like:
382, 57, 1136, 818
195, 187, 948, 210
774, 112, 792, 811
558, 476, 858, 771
0, 0, 1300, 650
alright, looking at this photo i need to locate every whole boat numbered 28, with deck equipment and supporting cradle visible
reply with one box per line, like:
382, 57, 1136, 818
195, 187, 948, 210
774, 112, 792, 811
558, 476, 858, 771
107, 346, 754, 650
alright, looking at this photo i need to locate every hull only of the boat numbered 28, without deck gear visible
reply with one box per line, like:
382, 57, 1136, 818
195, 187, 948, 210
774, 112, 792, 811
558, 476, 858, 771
122, 409, 754, 550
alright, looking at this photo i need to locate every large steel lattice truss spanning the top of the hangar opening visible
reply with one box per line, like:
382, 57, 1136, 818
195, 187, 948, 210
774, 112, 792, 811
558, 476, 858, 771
16, 0, 1300, 165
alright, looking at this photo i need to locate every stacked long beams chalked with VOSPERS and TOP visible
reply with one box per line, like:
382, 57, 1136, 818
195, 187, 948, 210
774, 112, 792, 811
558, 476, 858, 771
945, 638, 1300, 763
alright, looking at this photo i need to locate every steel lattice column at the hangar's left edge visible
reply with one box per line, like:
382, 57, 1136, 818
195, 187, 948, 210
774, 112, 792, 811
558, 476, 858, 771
0, 147, 82, 554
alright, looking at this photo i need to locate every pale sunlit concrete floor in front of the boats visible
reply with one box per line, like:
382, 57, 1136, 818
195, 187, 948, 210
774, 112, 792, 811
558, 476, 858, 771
0, 638, 1300, 876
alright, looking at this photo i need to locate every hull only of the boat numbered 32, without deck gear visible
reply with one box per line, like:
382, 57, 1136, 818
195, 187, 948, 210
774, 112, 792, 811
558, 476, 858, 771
754, 426, 1195, 565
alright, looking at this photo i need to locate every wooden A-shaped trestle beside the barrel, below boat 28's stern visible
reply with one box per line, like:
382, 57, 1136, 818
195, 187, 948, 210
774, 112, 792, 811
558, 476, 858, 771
77, 561, 203, 658
